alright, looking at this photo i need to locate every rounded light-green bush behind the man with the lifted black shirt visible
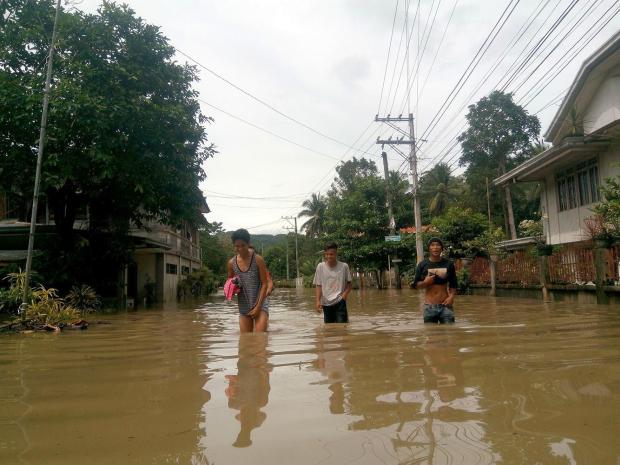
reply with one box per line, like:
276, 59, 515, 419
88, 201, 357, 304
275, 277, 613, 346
432, 207, 488, 257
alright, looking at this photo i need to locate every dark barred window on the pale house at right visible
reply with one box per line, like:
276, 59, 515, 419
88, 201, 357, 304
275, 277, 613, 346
556, 159, 599, 211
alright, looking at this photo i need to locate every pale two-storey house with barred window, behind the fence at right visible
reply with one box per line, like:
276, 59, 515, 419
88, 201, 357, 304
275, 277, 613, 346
493, 32, 620, 245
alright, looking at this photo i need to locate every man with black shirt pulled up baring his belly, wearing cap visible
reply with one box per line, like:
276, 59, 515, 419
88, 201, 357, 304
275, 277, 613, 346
414, 237, 457, 323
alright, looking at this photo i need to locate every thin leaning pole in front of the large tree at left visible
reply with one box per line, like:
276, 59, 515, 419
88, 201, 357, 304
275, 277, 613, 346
19, 0, 61, 317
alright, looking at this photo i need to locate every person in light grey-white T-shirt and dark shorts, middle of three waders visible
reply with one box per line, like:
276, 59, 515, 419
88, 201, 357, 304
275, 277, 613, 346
313, 242, 352, 323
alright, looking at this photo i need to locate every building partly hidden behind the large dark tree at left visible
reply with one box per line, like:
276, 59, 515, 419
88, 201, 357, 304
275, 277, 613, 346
0, 192, 210, 303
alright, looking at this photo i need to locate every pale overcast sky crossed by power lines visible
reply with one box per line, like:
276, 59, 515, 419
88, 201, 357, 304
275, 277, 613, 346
71, 0, 620, 234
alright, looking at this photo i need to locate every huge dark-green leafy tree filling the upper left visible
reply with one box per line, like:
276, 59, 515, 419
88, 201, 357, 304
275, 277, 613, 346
0, 0, 215, 290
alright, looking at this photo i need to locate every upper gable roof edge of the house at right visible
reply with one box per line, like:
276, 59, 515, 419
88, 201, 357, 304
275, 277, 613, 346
545, 31, 620, 142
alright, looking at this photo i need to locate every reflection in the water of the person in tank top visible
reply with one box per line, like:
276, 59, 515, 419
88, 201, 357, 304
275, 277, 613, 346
225, 333, 271, 447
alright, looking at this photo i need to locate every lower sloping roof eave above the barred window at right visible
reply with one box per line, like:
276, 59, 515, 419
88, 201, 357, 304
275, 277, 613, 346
493, 137, 610, 186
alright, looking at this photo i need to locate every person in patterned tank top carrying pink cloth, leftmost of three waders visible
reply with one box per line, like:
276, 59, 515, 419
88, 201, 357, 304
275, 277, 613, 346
228, 229, 269, 333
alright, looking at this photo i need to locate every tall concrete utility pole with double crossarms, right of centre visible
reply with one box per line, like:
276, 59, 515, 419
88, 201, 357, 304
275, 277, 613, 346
375, 113, 424, 263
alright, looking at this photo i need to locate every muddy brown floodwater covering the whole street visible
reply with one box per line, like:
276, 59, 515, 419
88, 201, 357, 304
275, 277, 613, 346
0, 289, 620, 465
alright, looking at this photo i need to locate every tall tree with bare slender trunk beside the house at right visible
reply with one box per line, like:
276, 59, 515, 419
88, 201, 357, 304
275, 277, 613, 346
459, 91, 540, 238
